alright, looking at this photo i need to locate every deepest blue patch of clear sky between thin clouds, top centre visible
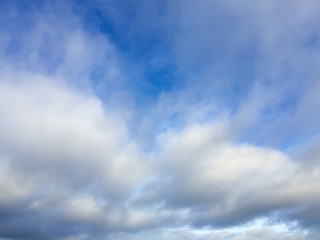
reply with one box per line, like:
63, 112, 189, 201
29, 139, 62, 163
75, 1, 177, 105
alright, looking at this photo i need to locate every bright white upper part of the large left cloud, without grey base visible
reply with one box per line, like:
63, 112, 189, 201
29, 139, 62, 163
0, 76, 147, 205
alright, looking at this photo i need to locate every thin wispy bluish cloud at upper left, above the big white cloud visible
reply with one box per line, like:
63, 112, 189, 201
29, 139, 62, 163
0, 1, 126, 101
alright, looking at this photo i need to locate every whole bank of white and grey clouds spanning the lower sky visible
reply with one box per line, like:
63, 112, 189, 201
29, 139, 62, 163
0, 75, 320, 238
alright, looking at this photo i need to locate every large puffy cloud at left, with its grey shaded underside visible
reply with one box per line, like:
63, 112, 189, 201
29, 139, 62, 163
0, 76, 148, 239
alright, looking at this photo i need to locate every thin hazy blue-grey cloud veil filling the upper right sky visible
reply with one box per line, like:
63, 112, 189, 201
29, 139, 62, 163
156, 1, 320, 147
